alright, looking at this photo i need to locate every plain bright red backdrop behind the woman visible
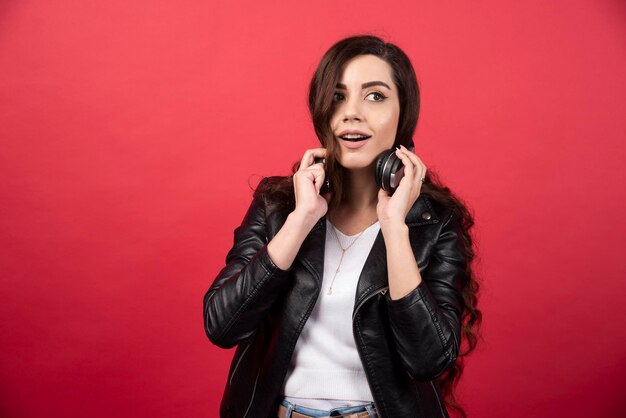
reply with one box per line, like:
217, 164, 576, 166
0, 0, 626, 418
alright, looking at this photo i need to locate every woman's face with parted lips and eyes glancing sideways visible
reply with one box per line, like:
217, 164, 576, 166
330, 55, 400, 169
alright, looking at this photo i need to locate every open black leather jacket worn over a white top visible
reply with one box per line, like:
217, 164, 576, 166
204, 180, 467, 418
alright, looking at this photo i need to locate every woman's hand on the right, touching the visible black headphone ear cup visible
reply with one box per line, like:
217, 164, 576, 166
376, 145, 426, 229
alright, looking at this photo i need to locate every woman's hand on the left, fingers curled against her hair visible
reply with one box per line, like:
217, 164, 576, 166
293, 148, 330, 223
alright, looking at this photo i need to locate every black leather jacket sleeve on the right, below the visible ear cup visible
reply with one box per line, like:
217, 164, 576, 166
387, 209, 468, 380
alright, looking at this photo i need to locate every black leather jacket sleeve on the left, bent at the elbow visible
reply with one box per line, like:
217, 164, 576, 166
204, 179, 289, 348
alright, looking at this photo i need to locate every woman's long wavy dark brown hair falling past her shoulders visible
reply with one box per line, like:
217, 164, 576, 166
255, 35, 482, 417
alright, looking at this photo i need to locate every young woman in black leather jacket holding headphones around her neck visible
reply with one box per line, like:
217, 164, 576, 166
204, 36, 481, 418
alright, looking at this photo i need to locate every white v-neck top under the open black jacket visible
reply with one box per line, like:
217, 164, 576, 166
283, 220, 380, 409
